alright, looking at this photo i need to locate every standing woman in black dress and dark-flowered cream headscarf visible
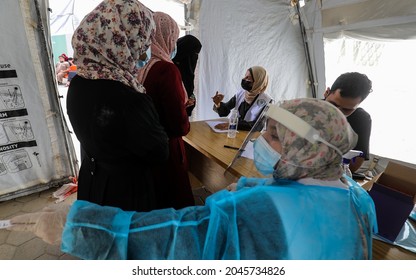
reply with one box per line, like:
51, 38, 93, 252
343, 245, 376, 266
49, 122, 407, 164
67, 0, 168, 211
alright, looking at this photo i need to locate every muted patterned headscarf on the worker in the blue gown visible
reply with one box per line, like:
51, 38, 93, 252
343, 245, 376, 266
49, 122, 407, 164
273, 98, 357, 180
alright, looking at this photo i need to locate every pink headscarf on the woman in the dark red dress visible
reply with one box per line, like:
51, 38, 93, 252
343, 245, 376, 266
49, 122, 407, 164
137, 12, 179, 84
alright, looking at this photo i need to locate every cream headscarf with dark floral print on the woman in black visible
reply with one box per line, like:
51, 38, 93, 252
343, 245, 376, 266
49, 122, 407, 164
72, 0, 155, 93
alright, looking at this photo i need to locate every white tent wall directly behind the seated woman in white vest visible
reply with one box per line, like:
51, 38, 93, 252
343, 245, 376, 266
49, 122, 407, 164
191, 0, 311, 119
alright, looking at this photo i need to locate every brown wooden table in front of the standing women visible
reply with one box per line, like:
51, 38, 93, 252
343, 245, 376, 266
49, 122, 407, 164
184, 121, 416, 260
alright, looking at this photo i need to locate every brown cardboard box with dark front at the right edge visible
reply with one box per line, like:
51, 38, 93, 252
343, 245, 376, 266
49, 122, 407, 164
369, 162, 416, 242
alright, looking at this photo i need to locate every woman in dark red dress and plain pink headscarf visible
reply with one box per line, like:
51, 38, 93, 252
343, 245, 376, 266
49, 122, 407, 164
138, 12, 195, 209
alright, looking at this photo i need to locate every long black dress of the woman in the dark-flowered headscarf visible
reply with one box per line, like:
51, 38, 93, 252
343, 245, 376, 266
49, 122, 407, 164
67, 76, 169, 211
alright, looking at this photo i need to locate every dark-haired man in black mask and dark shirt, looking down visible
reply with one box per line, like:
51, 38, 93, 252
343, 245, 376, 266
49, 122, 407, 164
324, 72, 372, 172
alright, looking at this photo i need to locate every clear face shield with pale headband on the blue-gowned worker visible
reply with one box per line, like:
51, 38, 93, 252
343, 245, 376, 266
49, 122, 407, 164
226, 103, 342, 177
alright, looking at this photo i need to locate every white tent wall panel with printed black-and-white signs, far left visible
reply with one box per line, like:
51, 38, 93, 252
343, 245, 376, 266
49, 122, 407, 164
0, 0, 77, 201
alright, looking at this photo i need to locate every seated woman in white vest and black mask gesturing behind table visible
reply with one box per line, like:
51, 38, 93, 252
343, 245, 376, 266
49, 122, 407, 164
212, 66, 272, 130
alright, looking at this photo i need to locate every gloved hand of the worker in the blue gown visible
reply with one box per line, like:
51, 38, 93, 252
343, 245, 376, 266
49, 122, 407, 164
8, 203, 71, 245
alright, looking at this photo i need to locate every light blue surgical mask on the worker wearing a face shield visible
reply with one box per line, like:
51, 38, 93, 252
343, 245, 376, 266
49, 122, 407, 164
254, 136, 281, 176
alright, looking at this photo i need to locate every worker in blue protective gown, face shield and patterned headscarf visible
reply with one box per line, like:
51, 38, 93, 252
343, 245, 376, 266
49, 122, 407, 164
57, 98, 377, 260
